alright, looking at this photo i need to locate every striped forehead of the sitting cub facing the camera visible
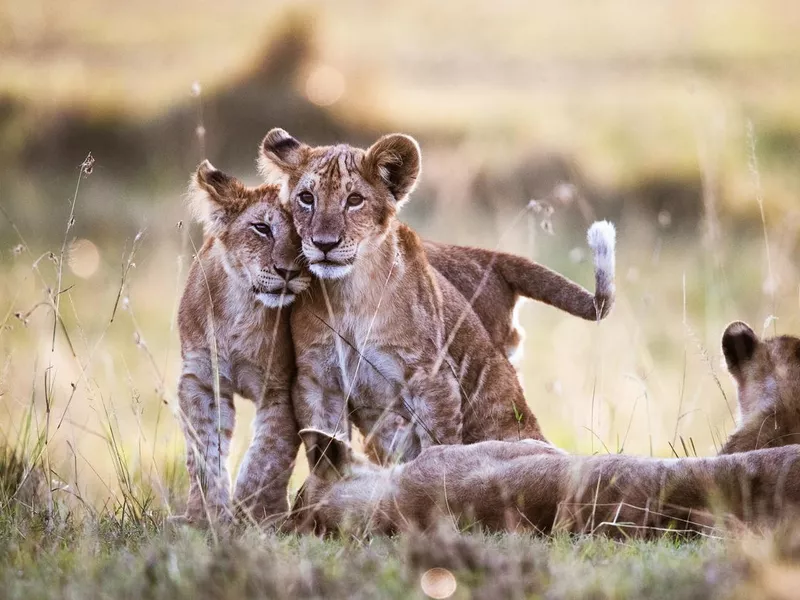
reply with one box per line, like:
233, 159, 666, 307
298, 144, 364, 194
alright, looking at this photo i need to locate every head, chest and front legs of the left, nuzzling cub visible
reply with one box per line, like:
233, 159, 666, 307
178, 161, 309, 522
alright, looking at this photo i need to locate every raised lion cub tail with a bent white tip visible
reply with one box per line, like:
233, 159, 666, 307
497, 221, 616, 321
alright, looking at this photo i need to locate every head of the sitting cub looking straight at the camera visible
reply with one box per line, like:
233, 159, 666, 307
259, 129, 421, 279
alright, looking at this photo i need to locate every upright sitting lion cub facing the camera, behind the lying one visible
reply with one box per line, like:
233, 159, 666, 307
261, 129, 613, 459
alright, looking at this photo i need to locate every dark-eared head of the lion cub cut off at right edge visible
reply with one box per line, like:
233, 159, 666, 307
722, 321, 800, 454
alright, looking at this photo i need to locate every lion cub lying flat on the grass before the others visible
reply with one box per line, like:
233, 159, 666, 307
290, 430, 800, 538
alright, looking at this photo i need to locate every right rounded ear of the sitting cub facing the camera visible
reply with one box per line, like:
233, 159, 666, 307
364, 133, 422, 204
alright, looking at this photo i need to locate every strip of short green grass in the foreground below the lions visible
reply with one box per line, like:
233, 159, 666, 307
0, 502, 764, 600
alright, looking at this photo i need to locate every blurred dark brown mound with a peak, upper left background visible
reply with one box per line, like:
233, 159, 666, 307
0, 13, 371, 187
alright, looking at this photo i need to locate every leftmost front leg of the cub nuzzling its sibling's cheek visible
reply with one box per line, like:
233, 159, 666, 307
178, 351, 235, 523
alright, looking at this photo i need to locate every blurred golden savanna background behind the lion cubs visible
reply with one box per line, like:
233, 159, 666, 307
0, 0, 800, 504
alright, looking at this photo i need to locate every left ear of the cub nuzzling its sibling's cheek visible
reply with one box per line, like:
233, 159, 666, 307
189, 160, 244, 235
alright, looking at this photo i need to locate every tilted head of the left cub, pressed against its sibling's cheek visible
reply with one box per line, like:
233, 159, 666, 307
189, 160, 310, 308
